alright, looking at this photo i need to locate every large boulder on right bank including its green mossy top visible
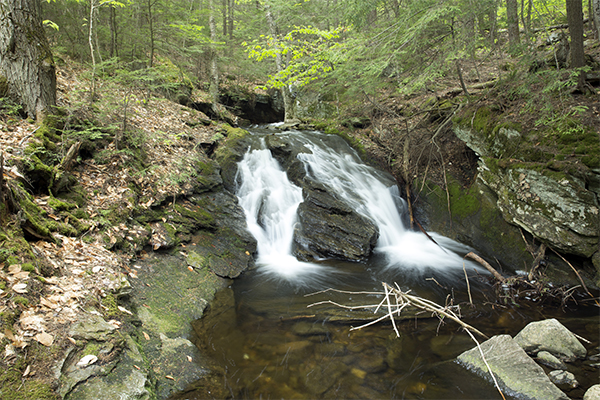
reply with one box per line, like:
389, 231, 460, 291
454, 119, 600, 258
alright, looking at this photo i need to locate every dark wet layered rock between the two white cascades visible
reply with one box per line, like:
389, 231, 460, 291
294, 184, 378, 261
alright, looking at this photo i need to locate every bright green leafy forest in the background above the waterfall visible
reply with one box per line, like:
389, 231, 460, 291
42, 0, 598, 108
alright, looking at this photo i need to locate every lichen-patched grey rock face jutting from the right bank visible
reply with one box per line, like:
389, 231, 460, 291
454, 126, 600, 280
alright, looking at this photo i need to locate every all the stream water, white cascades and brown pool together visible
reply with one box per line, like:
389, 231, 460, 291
182, 130, 598, 399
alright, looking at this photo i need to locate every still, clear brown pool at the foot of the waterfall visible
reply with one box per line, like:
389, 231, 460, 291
179, 263, 598, 399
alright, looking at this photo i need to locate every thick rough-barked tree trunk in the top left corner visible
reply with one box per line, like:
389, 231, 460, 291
0, 0, 56, 121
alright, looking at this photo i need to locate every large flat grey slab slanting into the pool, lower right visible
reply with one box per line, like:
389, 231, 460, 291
457, 335, 568, 400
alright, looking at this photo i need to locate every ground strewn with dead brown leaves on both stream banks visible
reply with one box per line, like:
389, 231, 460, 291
0, 36, 600, 398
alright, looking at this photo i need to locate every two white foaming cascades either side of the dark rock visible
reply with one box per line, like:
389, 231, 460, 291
237, 132, 473, 279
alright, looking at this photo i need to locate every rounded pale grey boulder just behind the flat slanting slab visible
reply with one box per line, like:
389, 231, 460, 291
515, 318, 587, 361
